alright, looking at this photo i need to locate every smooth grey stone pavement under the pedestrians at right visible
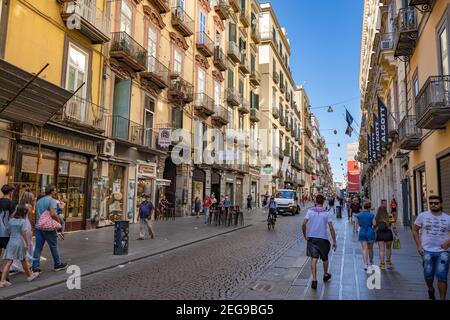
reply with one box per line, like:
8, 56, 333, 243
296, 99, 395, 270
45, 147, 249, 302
237, 208, 428, 300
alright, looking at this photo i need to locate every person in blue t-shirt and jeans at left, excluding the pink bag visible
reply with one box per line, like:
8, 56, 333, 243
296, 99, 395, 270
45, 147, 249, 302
32, 185, 67, 273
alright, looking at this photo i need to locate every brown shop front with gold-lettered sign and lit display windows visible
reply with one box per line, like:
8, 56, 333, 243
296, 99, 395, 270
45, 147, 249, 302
14, 125, 99, 231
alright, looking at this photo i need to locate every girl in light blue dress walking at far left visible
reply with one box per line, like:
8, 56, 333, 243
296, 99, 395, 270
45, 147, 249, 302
0, 205, 39, 288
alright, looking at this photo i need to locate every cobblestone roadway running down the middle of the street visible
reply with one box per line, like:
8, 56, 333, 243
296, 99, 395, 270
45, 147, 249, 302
15, 210, 304, 300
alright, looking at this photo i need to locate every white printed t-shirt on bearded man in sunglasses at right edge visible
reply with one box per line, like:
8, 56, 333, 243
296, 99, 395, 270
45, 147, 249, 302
414, 211, 450, 252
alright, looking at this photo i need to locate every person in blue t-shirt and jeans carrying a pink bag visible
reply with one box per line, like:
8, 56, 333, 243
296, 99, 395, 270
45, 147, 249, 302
32, 186, 67, 272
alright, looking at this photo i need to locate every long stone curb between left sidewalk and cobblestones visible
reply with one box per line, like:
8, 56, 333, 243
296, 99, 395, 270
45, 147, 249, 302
5, 224, 253, 300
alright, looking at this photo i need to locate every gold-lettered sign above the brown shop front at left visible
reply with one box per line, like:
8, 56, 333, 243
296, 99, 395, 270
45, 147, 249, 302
23, 125, 97, 154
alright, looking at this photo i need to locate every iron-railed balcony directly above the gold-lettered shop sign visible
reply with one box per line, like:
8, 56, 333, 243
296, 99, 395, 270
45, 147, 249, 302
52, 96, 106, 133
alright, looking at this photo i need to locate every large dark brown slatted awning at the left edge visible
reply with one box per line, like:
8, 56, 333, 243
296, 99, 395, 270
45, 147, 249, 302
0, 59, 73, 126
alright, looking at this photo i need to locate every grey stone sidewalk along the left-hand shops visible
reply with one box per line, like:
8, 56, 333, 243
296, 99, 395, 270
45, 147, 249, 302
0, 209, 266, 299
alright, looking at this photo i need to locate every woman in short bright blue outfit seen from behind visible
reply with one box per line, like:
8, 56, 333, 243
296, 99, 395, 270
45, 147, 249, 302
357, 200, 376, 271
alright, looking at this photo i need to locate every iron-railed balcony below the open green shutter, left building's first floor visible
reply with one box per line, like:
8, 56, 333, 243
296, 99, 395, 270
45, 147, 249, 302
111, 115, 144, 146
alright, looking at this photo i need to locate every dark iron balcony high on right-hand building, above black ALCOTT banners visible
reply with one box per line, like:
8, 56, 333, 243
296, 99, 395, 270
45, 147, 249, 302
394, 7, 419, 57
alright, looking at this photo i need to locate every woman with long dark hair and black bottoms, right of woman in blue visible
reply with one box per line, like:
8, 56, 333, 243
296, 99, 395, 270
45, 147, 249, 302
375, 206, 394, 270
